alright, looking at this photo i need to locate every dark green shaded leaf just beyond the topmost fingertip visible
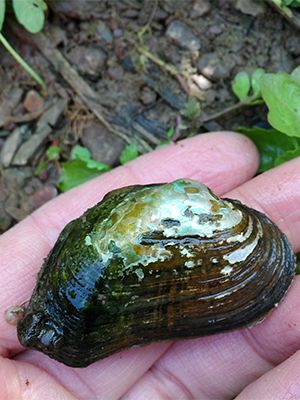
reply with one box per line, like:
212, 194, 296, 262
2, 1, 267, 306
238, 127, 300, 172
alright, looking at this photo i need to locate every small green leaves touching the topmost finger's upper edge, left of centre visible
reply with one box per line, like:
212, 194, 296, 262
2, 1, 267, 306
59, 145, 110, 192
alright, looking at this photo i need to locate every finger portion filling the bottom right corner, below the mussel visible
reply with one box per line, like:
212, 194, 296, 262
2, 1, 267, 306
236, 351, 300, 400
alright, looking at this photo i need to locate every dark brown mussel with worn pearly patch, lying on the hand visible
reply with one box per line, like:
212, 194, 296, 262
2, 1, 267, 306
18, 179, 295, 367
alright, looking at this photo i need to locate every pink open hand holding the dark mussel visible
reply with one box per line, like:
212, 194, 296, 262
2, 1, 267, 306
0, 132, 300, 400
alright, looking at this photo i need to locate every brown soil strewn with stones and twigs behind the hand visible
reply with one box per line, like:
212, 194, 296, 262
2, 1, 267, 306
0, 0, 300, 232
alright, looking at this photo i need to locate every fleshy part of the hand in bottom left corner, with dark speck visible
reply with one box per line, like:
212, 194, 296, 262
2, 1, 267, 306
0, 357, 77, 400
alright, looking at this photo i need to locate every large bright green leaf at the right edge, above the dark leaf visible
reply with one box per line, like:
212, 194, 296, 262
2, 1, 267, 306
261, 72, 300, 137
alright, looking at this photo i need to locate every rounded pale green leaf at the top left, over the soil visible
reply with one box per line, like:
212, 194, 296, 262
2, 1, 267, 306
12, 0, 47, 33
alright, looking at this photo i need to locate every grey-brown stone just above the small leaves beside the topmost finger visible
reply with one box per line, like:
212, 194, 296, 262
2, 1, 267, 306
81, 121, 125, 165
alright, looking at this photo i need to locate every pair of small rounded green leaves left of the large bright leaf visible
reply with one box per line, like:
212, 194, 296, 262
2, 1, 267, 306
231, 68, 265, 105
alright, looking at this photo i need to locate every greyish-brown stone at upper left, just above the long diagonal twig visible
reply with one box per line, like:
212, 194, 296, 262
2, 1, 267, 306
66, 46, 107, 78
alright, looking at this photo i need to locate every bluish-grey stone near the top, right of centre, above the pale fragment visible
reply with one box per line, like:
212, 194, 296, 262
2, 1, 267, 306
166, 21, 201, 51
